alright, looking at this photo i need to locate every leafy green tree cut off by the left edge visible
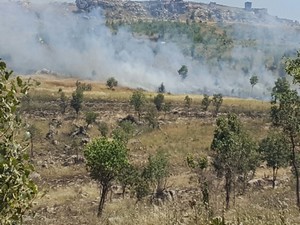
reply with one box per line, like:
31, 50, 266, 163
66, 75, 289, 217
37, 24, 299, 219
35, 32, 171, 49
0, 59, 37, 225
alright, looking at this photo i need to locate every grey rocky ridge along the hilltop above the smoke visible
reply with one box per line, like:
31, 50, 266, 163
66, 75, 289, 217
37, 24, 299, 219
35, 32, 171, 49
76, 0, 297, 25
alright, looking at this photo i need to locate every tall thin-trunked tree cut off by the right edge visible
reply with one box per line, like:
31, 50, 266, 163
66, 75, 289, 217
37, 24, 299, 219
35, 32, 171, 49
271, 78, 300, 208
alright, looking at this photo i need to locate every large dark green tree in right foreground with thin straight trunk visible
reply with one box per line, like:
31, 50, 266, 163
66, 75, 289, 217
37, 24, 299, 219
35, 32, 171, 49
211, 114, 257, 209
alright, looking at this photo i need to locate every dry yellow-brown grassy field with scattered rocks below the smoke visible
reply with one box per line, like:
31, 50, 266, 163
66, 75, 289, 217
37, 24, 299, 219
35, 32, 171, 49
17, 76, 300, 225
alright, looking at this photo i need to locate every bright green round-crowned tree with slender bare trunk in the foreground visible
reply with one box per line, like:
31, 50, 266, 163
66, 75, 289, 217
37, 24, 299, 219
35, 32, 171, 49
84, 138, 128, 217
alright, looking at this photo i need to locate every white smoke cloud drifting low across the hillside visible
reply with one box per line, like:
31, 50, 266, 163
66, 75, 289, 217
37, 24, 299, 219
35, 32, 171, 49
0, 1, 298, 97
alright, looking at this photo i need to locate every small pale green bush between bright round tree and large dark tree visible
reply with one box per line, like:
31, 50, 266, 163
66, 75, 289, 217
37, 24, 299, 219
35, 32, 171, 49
142, 149, 170, 192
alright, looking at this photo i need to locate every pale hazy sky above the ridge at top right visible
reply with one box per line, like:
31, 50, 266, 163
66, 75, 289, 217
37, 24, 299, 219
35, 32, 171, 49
194, 0, 300, 21
